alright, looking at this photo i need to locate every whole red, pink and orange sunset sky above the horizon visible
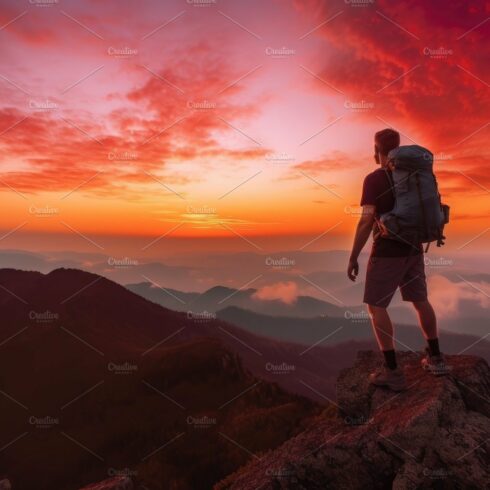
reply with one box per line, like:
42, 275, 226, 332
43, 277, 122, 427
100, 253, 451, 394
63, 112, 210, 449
0, 0, 490, 251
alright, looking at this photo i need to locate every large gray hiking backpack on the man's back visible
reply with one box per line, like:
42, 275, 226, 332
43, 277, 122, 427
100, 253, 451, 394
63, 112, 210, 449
377, 145, 449, 252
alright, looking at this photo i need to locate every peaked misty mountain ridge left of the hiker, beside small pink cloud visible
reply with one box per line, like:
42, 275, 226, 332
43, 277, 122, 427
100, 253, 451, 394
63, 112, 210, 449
126, 282, 344, 318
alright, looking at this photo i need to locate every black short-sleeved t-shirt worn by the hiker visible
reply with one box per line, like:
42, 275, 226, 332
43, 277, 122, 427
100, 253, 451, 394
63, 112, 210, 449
361, 168, 422, 257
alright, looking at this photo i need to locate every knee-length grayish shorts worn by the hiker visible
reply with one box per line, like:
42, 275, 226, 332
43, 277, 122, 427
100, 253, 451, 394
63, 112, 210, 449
364, 253, 427, 308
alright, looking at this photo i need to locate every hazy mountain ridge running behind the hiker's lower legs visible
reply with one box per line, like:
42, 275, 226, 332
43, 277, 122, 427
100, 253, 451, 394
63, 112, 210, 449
217, 306, 490, 361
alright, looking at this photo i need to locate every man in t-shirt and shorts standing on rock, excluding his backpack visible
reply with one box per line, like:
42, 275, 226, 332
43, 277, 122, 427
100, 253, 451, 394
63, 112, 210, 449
347, 129, 446, 391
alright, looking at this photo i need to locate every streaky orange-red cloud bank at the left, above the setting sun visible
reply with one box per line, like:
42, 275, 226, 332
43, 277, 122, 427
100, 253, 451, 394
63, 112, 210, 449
0, 39, 266, 194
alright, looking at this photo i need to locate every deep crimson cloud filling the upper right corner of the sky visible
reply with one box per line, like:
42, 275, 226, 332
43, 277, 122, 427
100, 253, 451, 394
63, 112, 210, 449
300, 0, 490, 154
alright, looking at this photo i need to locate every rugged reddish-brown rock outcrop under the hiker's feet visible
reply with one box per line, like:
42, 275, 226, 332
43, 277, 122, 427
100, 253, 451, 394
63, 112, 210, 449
215, 351, 490, 490
